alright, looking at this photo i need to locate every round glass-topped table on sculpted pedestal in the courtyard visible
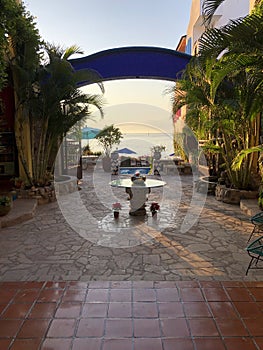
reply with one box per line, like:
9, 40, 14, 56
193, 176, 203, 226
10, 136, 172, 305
110, 179, 166, 216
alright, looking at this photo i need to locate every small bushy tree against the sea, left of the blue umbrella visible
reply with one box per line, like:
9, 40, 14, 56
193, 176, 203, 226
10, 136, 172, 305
95, 124, 123, 156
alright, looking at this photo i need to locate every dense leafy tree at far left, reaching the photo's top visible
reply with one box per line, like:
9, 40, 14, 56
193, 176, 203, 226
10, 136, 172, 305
3, 0, 41, 184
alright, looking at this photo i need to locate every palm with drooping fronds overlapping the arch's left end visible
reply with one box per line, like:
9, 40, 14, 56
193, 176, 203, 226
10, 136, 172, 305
28, 44, 103, 185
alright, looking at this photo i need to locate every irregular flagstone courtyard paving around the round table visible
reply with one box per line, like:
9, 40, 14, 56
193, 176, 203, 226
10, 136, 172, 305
0, 172, 263, 281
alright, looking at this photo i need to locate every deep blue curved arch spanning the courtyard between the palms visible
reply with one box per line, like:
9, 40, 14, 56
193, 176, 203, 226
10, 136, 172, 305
69, 46, 192, 87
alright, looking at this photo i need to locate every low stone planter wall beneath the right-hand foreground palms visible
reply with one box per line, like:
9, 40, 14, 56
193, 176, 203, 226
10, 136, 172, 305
215, 185, 258, 204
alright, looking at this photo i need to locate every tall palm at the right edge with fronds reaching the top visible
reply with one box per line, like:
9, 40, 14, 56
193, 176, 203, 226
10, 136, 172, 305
200, 2, 263, 186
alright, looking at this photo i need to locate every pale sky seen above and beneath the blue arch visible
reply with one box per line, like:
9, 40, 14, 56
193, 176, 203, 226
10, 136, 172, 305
24, 0, 192, 132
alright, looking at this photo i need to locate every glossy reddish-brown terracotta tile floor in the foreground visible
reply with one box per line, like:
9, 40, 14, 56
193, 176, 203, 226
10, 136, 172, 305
0, 281, 263, 350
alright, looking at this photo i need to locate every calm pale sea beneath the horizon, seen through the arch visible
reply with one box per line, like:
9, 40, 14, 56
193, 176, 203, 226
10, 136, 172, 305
84, 133, 174, 158
